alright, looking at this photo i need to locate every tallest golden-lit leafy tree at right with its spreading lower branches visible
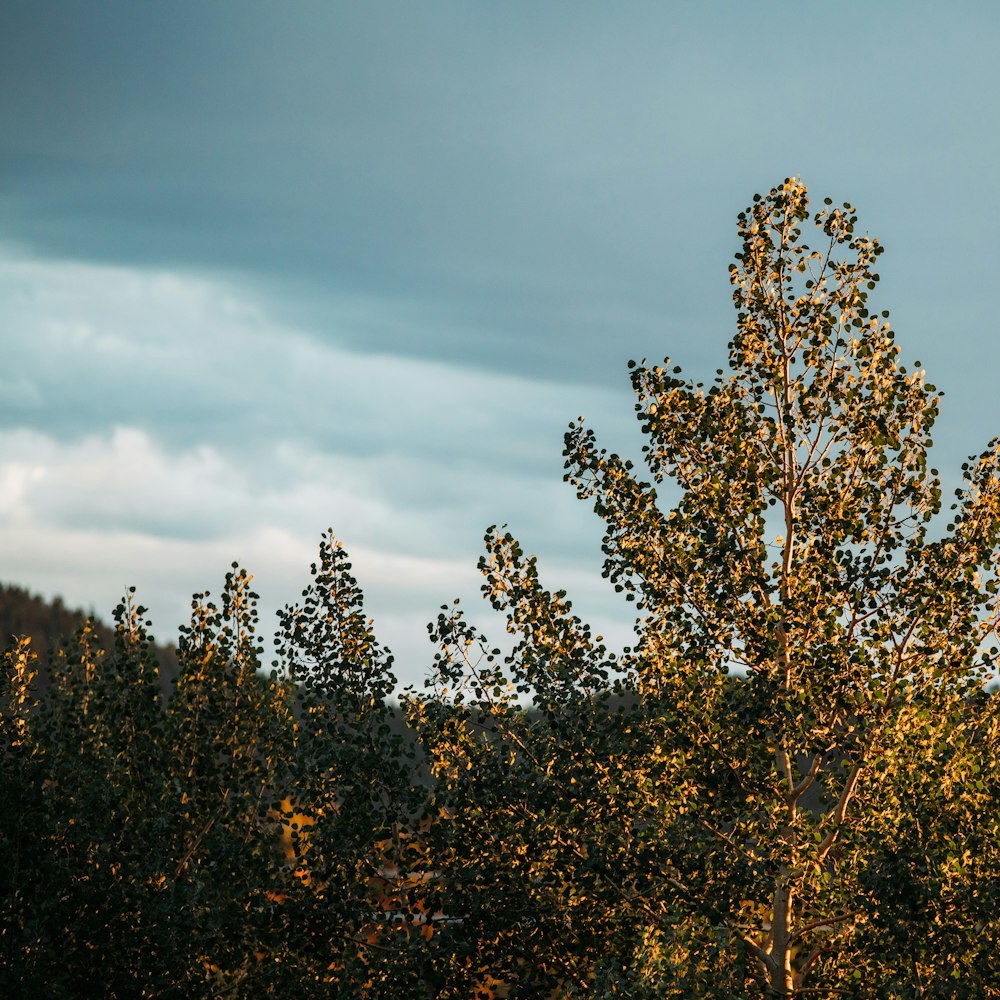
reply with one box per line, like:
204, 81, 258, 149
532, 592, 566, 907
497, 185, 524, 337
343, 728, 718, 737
409, 179, 1000, 998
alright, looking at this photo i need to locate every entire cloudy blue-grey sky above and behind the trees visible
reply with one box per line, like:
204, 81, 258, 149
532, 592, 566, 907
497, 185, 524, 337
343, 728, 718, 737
0, 0, 1000, 685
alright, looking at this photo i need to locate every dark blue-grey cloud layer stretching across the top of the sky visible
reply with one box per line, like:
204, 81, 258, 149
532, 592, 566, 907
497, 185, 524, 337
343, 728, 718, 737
17, 2, 1000, 386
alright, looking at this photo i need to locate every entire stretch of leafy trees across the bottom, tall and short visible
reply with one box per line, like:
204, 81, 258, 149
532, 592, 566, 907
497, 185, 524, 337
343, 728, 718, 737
0, 178, 1000, 1000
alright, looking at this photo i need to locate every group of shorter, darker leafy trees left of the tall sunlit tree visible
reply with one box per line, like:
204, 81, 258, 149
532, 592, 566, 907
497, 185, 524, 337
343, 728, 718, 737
0, 552, 426, 998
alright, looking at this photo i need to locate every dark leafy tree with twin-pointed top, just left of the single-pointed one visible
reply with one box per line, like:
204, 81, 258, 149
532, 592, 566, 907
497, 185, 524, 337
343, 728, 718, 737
162, 563, 294, 996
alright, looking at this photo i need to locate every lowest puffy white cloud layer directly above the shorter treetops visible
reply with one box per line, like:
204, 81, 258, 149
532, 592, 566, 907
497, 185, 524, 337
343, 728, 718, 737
0, 428, 628, 683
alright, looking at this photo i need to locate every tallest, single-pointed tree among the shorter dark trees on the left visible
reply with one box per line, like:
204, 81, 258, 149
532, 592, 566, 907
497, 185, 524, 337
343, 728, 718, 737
278, 532, 434, 998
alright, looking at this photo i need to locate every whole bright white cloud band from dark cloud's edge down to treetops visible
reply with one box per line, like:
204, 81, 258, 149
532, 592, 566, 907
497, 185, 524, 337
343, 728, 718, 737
0, 251, 640, 682
